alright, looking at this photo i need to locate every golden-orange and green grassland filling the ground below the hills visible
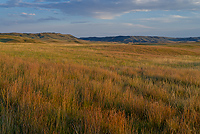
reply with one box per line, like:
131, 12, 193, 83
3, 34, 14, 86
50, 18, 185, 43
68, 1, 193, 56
0, 42, 200, 134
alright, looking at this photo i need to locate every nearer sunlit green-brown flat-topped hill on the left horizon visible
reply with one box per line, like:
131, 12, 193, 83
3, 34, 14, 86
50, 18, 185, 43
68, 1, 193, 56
0, 33, 82, 43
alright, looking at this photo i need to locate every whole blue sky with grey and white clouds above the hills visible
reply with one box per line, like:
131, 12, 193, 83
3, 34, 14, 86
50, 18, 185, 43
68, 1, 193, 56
0, 0, 200, 37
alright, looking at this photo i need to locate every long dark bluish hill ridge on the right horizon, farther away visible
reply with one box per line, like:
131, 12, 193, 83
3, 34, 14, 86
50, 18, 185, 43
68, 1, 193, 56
80, 36, 200, 43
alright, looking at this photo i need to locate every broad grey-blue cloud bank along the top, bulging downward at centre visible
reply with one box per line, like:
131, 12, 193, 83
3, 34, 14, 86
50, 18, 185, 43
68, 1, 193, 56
0, 0, 200, 19
